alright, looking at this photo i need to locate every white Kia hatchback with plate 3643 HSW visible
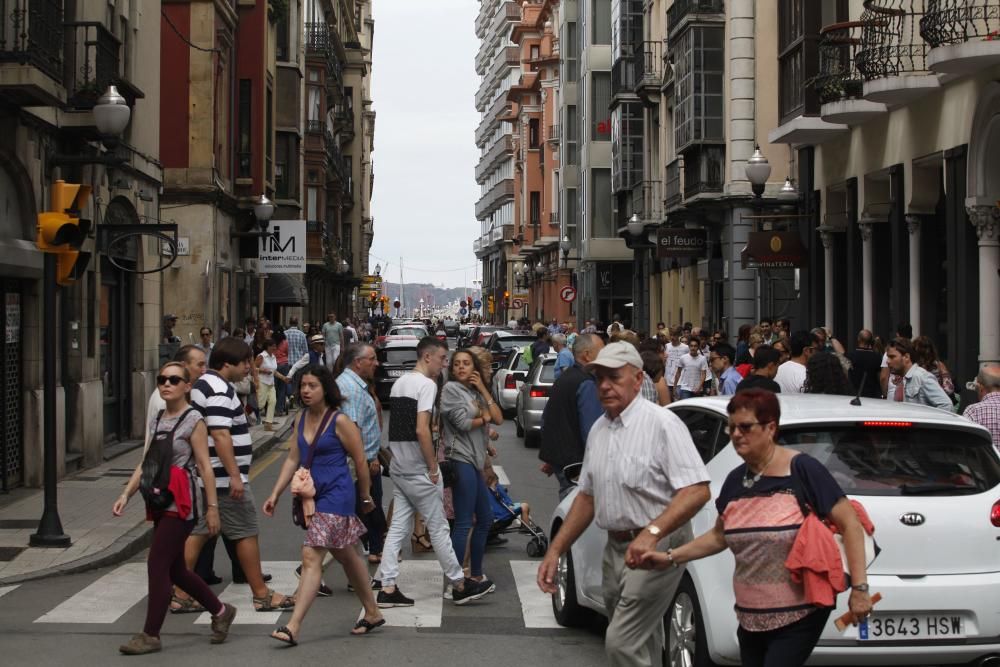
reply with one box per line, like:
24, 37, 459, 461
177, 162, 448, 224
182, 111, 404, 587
550, 395, 1000, 667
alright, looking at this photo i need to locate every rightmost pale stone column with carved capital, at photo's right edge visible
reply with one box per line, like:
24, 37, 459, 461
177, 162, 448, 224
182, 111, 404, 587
966, 205, 1000, 365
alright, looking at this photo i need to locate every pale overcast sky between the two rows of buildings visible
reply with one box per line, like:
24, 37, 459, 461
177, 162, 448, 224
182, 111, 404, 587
370, 0, 479, 287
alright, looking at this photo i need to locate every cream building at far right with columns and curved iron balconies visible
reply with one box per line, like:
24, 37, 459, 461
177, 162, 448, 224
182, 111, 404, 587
771, 0, 1000, 396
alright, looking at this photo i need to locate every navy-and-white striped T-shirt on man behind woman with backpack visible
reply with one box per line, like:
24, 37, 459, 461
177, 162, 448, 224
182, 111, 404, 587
191, 370, 253, 489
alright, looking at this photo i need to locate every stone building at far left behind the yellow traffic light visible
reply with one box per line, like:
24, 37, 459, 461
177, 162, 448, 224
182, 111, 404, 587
0, 0, 163, 489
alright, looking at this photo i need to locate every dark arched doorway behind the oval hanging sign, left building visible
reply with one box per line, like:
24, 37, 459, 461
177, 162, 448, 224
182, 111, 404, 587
99, 197, 140, 443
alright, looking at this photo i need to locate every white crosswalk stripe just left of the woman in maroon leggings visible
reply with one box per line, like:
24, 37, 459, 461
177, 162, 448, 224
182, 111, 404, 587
35, 563, 147, 623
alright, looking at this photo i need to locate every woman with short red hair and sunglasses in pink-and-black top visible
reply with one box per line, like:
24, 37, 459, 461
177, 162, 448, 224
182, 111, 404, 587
640, 389, 872, 667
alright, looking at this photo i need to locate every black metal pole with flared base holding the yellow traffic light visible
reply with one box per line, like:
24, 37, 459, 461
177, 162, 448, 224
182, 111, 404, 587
28, 252, 70, 548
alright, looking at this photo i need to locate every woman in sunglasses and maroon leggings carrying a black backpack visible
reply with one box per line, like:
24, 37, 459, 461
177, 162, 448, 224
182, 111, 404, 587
111, 361, 236, 655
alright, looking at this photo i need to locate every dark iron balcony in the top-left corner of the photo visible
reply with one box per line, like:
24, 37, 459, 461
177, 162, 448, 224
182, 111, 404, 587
0, 0, 63, 106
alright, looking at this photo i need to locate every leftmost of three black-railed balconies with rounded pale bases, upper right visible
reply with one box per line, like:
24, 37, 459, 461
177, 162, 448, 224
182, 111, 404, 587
808, 21, 887, 125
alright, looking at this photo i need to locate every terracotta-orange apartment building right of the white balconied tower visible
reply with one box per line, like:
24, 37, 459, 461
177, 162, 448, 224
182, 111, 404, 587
501, 0, 576, 322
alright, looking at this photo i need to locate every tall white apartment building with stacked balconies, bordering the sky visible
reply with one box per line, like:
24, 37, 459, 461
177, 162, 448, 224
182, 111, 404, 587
473, 0, 521, 322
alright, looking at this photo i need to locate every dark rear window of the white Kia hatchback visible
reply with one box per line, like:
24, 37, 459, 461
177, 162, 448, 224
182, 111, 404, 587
779, 425, 1000, 496
